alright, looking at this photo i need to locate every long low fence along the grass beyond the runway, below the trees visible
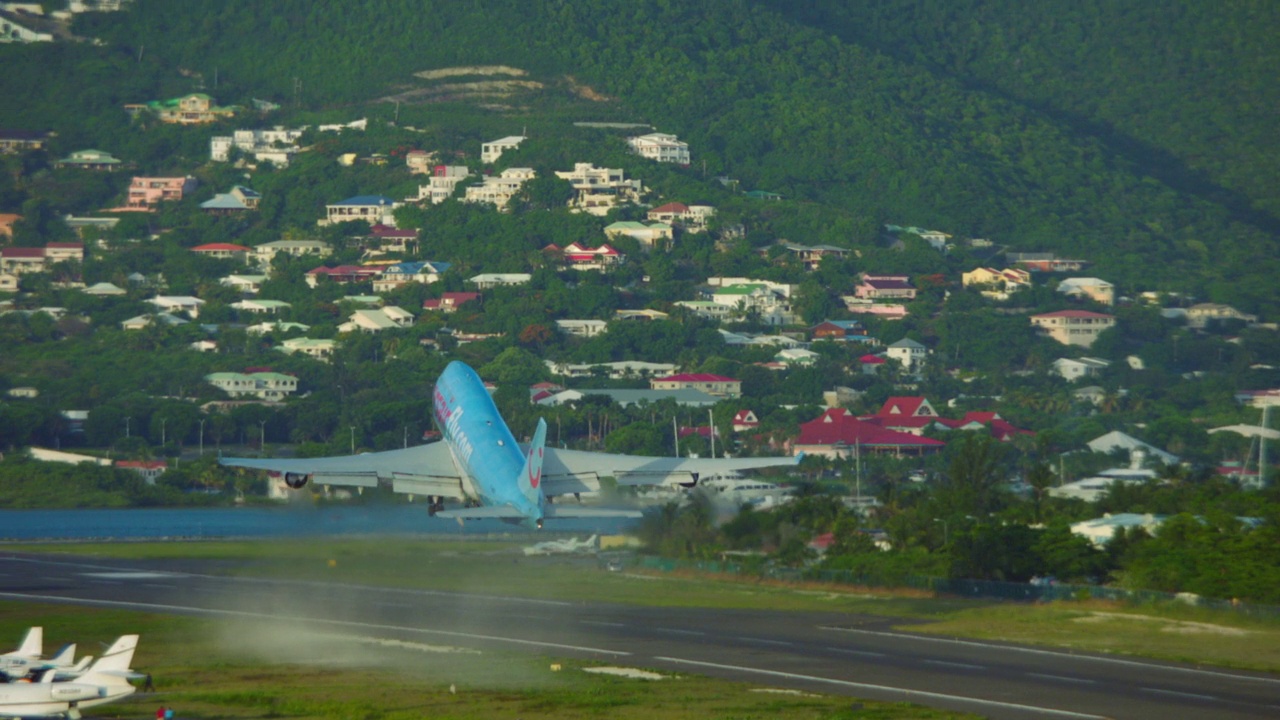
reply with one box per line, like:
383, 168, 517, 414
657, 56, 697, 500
637, 556, 1280, 619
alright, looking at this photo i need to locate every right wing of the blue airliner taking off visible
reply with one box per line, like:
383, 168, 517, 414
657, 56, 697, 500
543, 447, 800, 492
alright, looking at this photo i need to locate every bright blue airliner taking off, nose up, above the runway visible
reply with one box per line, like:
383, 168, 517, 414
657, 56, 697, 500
219, 360, 800, 528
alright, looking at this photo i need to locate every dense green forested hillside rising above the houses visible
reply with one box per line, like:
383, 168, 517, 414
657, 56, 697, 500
0, 0, 1280, 314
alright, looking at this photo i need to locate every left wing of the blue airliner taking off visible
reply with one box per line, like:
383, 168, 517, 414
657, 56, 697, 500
218, 442, 463, 498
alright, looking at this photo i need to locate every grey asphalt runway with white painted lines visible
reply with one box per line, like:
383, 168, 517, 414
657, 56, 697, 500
0, 545, 1280, 720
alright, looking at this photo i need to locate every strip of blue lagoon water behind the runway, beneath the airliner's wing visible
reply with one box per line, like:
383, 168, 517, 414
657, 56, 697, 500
0, 505, 626, 541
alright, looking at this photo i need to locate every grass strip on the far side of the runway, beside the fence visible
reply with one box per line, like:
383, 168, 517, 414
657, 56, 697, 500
20, 538, 1280, 673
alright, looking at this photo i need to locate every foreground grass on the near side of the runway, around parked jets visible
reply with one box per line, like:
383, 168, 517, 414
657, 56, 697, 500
0, 602, 973, 720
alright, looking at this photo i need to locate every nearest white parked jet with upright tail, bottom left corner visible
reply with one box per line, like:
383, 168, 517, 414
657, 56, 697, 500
0, 635, 138, 720
